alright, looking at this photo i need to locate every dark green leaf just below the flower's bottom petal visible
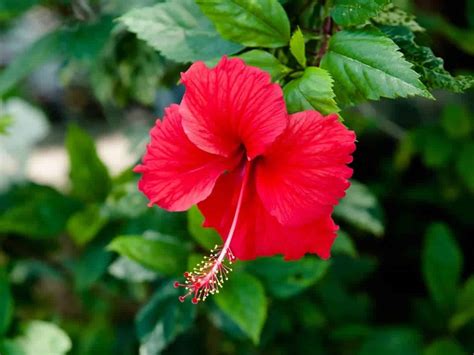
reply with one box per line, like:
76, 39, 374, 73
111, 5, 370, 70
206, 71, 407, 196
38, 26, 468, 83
246, 256, 330, 298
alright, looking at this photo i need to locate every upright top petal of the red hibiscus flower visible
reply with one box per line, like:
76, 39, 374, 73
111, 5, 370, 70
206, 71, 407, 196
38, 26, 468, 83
180, 57, 288, 159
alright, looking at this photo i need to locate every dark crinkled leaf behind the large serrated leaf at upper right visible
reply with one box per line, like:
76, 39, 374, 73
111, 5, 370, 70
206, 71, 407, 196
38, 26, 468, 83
381, 26, 474, 93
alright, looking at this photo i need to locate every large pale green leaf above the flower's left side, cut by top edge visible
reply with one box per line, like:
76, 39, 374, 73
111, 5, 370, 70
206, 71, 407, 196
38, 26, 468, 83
119, 0, 242, 63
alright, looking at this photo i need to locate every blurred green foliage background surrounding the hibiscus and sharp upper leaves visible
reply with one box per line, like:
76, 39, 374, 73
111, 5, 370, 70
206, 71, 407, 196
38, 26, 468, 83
0, 0, 474, 355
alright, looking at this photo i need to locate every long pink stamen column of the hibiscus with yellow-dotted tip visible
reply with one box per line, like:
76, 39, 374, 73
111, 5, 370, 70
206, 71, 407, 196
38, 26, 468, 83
174, 161, 252, 304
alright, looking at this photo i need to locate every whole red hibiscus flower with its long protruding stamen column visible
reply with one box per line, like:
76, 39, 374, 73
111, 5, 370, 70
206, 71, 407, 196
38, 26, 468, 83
135, 57, 355, 303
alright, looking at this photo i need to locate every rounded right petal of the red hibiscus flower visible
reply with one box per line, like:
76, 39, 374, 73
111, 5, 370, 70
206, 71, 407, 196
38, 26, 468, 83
256, 111, 355, 226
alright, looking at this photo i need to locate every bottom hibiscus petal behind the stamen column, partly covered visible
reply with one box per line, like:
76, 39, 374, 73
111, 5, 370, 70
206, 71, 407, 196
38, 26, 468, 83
198, 170, 338, 260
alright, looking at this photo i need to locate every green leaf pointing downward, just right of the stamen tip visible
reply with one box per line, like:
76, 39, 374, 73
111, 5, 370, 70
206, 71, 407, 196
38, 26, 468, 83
214, 272, 267, 344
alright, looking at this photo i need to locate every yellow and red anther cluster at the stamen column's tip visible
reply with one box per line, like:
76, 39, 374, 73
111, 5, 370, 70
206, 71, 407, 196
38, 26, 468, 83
174, 245, 235, 304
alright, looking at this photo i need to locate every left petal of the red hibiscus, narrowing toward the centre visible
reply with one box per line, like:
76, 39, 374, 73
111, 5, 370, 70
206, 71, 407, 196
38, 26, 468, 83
134, 105, 240, 211
